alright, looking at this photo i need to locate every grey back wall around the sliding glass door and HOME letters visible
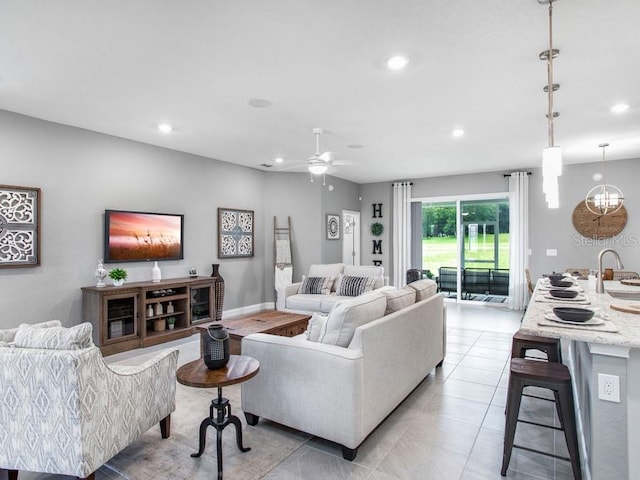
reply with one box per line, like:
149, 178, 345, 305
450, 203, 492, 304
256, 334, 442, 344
361, 163, 640, 284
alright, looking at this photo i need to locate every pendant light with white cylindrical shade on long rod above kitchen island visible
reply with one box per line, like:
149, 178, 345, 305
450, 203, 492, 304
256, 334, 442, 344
538, 0, 562, 208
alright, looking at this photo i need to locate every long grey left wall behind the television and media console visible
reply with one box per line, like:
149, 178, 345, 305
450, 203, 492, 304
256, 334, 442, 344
0, 111, 359, 328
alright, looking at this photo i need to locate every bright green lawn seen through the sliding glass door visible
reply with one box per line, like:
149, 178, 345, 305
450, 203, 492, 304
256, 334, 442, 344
422, 233, 509, 276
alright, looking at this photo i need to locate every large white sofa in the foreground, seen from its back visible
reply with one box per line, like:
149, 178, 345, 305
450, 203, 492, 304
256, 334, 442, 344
242, 280, 446, 460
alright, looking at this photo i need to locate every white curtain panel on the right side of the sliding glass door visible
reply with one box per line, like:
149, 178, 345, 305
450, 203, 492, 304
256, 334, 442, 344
509, 172, 529, 310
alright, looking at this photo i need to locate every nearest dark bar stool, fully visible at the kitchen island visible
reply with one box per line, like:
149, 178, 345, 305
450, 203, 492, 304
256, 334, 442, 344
500, 358, 582, 480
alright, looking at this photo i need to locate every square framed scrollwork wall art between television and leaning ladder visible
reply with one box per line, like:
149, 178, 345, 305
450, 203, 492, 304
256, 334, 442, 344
218, 208, 254, 258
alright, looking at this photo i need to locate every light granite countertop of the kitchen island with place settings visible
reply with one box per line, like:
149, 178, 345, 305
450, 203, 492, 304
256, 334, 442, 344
520, 279, 640, 348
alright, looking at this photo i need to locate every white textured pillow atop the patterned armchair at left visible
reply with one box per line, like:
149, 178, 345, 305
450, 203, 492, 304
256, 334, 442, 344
14, 322, 93, 350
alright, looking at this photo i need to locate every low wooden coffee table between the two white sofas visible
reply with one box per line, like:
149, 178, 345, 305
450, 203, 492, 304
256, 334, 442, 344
197, 310, 311, 355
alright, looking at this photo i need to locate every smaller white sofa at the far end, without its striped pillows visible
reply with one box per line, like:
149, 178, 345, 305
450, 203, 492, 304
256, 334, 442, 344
276, 263, 388, 313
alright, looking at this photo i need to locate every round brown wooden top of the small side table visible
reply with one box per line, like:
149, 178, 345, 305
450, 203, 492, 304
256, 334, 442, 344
176, 355, 260, 388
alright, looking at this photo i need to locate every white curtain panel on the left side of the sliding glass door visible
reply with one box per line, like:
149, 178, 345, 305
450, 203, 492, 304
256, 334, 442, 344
393, 182, 411, 288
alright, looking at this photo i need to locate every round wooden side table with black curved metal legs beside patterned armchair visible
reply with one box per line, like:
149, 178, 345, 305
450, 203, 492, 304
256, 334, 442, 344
176, 355, 260, 480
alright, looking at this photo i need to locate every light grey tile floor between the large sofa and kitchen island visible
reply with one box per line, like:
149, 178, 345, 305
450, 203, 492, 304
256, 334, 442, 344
16, 301, 572, 480
